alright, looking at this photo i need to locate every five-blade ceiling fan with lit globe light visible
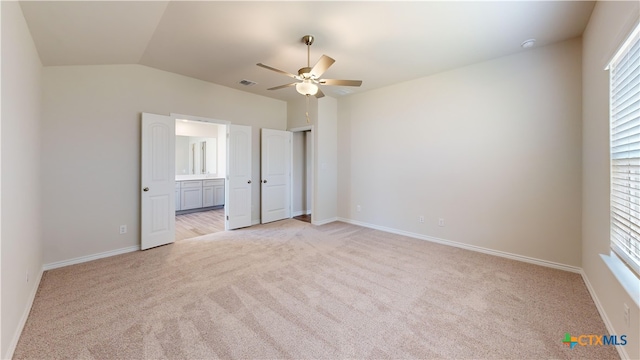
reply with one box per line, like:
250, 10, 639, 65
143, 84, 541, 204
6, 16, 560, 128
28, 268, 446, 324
256, 35, 362, 98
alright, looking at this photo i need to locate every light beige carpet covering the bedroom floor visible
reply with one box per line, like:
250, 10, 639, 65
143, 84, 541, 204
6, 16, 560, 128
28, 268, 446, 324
15, 220, 618, 359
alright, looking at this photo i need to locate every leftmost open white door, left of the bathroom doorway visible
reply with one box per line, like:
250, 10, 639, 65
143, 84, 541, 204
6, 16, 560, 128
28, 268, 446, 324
140, 113, 176, 250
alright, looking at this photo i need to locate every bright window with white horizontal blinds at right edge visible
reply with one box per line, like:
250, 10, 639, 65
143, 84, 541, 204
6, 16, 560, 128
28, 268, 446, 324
608, 22, 640, 274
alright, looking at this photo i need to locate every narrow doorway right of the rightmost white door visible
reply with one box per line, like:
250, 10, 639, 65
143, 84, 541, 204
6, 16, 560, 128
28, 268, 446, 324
291, 127, 313, 223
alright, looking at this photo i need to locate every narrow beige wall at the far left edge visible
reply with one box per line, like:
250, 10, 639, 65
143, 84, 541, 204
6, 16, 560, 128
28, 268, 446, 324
0, 1, 43, 359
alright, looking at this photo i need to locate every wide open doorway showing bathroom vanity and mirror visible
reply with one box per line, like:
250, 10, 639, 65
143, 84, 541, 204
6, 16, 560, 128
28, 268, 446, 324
175, 116, 227, 241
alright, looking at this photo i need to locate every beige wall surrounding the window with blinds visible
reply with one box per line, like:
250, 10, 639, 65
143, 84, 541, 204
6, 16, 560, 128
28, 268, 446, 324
582, 1, 640, 359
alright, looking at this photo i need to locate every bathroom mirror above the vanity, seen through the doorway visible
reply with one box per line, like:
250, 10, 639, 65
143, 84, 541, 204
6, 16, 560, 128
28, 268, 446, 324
176, 135, 218, 175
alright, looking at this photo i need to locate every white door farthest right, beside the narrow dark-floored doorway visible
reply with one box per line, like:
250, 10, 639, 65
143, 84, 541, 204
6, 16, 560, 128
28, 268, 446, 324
260, 129, 291, 224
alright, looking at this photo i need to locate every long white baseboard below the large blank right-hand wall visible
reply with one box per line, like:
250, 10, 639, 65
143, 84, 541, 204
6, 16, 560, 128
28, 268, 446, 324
337, 218, 582, 274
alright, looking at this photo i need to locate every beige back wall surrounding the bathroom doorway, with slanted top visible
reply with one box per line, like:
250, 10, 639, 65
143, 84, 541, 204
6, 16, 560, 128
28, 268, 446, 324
42, 65, 287, 264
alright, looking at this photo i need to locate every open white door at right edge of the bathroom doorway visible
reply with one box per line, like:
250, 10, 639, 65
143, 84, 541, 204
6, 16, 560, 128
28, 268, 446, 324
224, 125, 251, 230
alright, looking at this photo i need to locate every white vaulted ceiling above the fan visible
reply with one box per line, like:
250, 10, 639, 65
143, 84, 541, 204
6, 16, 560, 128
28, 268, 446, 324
21, 1, 594, 100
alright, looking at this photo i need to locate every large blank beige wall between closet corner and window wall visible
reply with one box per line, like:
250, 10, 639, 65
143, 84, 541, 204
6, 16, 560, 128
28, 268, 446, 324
338, 39, 581, 267
